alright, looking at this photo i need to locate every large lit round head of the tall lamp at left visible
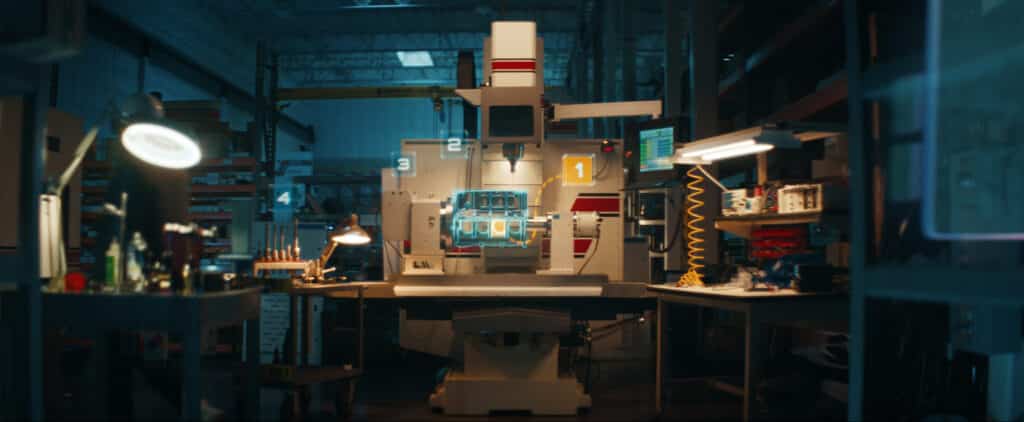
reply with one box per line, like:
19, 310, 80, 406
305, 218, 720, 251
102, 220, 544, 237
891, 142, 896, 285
121, 93, 203, 169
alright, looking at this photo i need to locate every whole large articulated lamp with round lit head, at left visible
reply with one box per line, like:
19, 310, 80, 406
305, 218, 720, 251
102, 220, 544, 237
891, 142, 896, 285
39, 93, 202, 289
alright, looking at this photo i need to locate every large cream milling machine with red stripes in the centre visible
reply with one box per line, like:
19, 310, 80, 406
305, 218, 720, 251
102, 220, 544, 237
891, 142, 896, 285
381, 22, 662, 415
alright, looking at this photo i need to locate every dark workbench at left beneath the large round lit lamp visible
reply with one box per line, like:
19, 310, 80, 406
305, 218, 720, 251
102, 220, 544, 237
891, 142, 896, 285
42, 288, 262, 421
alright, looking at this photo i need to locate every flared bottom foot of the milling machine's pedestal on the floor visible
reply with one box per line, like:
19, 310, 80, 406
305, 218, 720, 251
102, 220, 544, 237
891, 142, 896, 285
430, 372, 591, 415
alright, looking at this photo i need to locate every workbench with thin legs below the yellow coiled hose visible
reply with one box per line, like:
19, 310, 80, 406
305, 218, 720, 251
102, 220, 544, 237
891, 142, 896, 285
647, 285, 849, 421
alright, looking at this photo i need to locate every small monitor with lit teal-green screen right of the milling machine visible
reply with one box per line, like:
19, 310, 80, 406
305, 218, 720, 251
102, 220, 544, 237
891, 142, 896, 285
623, 118, 683, 184
